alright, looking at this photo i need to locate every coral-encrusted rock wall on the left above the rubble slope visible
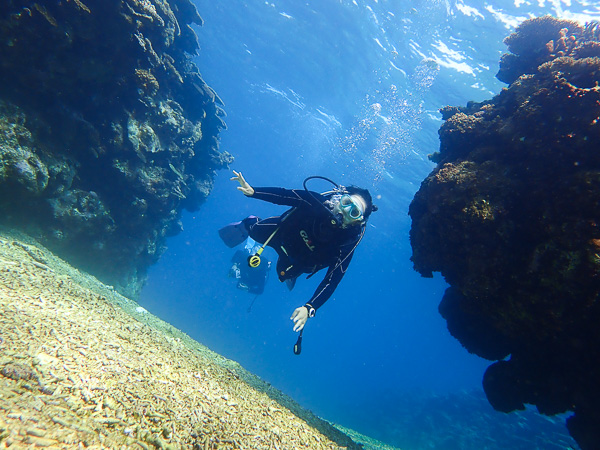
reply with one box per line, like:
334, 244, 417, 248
0, 0, 232, 298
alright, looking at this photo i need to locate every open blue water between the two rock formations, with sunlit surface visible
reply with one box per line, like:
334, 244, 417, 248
140, 0, 600, 448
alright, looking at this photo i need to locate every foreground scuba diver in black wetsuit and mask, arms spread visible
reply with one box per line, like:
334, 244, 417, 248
219, 171, 377, 336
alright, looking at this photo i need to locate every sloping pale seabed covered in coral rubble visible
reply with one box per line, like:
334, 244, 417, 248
0, 229, 396, 449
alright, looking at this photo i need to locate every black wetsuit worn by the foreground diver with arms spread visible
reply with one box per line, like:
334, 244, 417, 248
243, 187, 364, 310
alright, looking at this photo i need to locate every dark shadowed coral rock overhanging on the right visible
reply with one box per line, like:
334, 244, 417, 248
409, 17, 600, 449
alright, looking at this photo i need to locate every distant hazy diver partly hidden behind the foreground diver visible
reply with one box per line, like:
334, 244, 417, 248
229, 237, 271, 295
